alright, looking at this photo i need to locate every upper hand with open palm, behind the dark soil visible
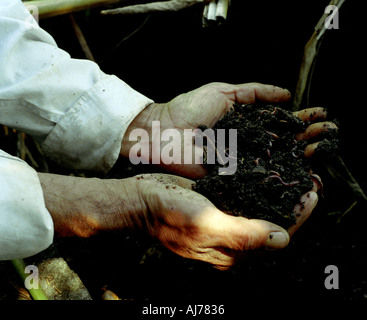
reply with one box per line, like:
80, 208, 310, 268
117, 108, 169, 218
120, 83, 336, 178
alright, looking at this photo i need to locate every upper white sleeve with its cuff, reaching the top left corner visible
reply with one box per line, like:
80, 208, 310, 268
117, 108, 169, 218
0, 0, 153, 171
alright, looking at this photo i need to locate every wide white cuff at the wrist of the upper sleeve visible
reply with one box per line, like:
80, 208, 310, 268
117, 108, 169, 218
42, 74, 153, 172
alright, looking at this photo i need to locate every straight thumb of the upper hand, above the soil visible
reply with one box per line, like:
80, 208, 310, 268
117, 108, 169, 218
235, 82, 291, 103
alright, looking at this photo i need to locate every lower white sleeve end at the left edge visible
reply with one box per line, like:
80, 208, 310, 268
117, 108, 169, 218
0, 150, 54, 260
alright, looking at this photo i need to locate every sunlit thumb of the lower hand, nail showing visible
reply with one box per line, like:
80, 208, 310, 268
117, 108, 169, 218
216, 215, 289, 251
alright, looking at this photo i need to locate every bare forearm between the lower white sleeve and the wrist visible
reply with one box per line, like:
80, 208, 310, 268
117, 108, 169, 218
38, 173, 146, 237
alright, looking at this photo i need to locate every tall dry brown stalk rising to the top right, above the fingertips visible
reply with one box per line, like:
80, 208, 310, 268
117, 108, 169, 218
293, 0, 345, 111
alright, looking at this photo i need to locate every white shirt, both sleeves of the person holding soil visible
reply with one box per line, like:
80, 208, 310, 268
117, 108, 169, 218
0, 0, 153, 260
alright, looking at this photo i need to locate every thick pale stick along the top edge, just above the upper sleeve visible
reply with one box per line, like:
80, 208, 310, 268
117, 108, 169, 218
23, 0, 127, 18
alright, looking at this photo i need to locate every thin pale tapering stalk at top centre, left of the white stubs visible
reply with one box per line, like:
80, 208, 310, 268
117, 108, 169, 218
101, 0, 208, 14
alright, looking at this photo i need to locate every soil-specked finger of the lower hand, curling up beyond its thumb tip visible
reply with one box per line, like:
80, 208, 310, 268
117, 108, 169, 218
288, 191, 318, 236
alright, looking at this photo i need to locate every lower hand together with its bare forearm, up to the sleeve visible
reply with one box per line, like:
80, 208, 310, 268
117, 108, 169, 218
38, 173, 318, 269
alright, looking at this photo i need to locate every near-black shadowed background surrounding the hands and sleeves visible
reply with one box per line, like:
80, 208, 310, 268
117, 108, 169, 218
1, 0, 367, 311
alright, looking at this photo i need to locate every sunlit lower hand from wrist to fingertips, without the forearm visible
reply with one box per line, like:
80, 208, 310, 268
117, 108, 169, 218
138, 174, 318, 270
